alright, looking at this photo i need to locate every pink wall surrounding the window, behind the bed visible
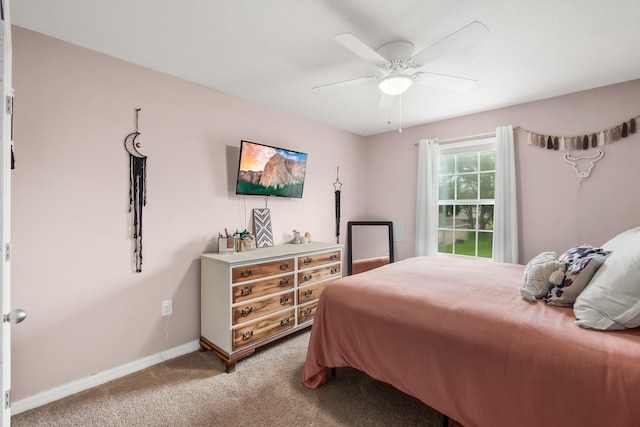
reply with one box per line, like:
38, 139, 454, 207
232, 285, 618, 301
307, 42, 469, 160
366, 80, 640, 262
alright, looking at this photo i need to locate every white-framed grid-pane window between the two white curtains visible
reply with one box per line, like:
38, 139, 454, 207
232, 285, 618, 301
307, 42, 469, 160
438, 138, 496, 258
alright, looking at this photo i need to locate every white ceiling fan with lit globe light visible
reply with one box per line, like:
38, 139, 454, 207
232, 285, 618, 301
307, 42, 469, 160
313, 21, 489, 109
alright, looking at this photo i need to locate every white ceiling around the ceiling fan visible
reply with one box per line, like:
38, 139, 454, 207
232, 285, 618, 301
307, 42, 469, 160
10, 0, 640, 136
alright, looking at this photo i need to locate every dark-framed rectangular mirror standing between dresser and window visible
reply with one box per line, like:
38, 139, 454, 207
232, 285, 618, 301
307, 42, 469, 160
347, 221, 393, 276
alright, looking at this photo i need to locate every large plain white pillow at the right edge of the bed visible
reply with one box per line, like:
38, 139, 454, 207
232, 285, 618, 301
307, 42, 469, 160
573, 227, 640, 330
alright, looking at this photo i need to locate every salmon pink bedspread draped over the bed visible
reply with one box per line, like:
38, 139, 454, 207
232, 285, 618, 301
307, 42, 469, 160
303, 256, 640, 427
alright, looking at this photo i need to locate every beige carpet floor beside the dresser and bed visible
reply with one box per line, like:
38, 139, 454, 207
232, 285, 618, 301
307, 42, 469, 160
11, 330, 460, 427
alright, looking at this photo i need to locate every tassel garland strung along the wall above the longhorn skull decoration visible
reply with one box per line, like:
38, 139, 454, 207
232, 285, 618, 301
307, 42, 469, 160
519, 117, 640, 151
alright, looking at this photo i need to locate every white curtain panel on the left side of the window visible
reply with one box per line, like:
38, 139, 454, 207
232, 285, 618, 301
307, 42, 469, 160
416, 139, 440, 256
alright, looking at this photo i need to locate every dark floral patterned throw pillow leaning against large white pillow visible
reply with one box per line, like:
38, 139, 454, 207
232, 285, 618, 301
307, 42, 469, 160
544, 245, 611, 307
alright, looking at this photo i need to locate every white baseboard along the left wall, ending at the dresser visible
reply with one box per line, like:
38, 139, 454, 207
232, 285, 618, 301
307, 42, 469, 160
11, 340, 200, 415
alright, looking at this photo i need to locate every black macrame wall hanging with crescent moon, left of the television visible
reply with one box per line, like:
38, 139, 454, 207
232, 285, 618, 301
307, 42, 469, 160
124, 108, 147, 273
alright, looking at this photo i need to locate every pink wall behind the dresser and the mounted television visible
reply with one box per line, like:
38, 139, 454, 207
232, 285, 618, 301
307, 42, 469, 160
12, 28, 364, 400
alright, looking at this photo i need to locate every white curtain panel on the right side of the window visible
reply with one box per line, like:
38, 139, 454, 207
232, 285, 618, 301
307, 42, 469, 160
493, 126, 518, 264
